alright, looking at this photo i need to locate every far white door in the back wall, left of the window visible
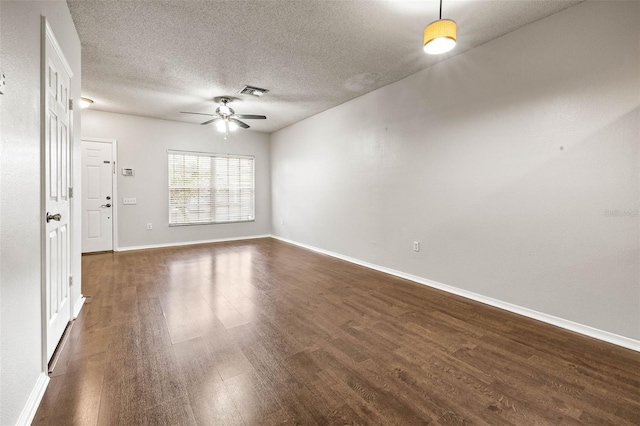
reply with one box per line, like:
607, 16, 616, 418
82, 140, 114, 253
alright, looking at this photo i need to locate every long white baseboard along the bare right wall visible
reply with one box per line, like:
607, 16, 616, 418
271, 235, 640, 352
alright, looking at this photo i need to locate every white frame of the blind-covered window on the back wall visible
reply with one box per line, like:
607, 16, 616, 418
167, 150, 256, 227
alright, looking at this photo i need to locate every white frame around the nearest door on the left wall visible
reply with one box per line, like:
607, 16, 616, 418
40, 16, 75, 372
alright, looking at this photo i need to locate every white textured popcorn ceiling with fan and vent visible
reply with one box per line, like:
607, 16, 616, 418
67, 0, 581, 132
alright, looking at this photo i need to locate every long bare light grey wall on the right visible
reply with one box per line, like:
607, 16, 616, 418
271, 2, 640, 340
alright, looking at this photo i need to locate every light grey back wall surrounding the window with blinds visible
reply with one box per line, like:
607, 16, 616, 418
82, 110, 271, 249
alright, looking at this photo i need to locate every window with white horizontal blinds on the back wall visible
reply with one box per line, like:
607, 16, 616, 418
169, 151, 255, 226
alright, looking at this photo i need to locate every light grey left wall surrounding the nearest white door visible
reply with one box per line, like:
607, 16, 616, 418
0, 0, 80, 425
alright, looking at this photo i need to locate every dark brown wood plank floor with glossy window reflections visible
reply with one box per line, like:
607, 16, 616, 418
34, 239, 640, 425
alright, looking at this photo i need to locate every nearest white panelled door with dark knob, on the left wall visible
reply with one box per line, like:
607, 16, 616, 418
43, 25, 73, 361
